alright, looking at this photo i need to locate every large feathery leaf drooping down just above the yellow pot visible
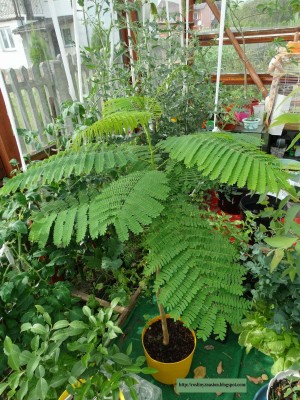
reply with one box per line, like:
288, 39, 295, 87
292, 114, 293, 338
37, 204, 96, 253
145, 201, 249, 340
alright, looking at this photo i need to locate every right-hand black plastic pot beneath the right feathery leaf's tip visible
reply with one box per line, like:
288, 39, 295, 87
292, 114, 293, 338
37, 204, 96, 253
240, 194, 280, 228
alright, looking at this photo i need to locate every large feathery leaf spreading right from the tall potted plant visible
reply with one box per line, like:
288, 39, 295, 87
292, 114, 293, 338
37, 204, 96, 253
161, 133, 292, 193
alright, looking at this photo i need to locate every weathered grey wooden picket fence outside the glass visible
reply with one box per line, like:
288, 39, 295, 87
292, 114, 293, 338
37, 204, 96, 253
2, 55, 90, 154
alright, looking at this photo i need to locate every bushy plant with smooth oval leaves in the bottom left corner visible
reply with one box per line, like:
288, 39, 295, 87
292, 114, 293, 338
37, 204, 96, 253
0, 299, 154, 400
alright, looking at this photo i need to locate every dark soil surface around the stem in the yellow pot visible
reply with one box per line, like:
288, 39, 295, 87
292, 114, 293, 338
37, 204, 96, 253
144, 318, 194, 363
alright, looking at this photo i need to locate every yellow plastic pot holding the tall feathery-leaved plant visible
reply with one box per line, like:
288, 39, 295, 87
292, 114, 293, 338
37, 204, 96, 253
142, 315, 197, 385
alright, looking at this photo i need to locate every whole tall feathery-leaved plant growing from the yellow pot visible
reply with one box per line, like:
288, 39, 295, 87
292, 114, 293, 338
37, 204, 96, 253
2, 97, 294, 386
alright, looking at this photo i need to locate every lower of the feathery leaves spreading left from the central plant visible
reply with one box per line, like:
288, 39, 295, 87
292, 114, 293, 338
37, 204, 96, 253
30, 171, 169, 248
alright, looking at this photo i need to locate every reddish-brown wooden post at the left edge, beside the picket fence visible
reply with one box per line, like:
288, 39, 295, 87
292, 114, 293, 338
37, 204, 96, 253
0, 90, 21, 177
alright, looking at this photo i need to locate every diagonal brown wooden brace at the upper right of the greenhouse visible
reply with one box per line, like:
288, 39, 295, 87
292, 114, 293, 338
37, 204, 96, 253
206, 0, 268, 97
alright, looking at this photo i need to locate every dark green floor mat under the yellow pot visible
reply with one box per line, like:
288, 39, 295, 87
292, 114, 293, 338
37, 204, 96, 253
119, 298, 272, 400
